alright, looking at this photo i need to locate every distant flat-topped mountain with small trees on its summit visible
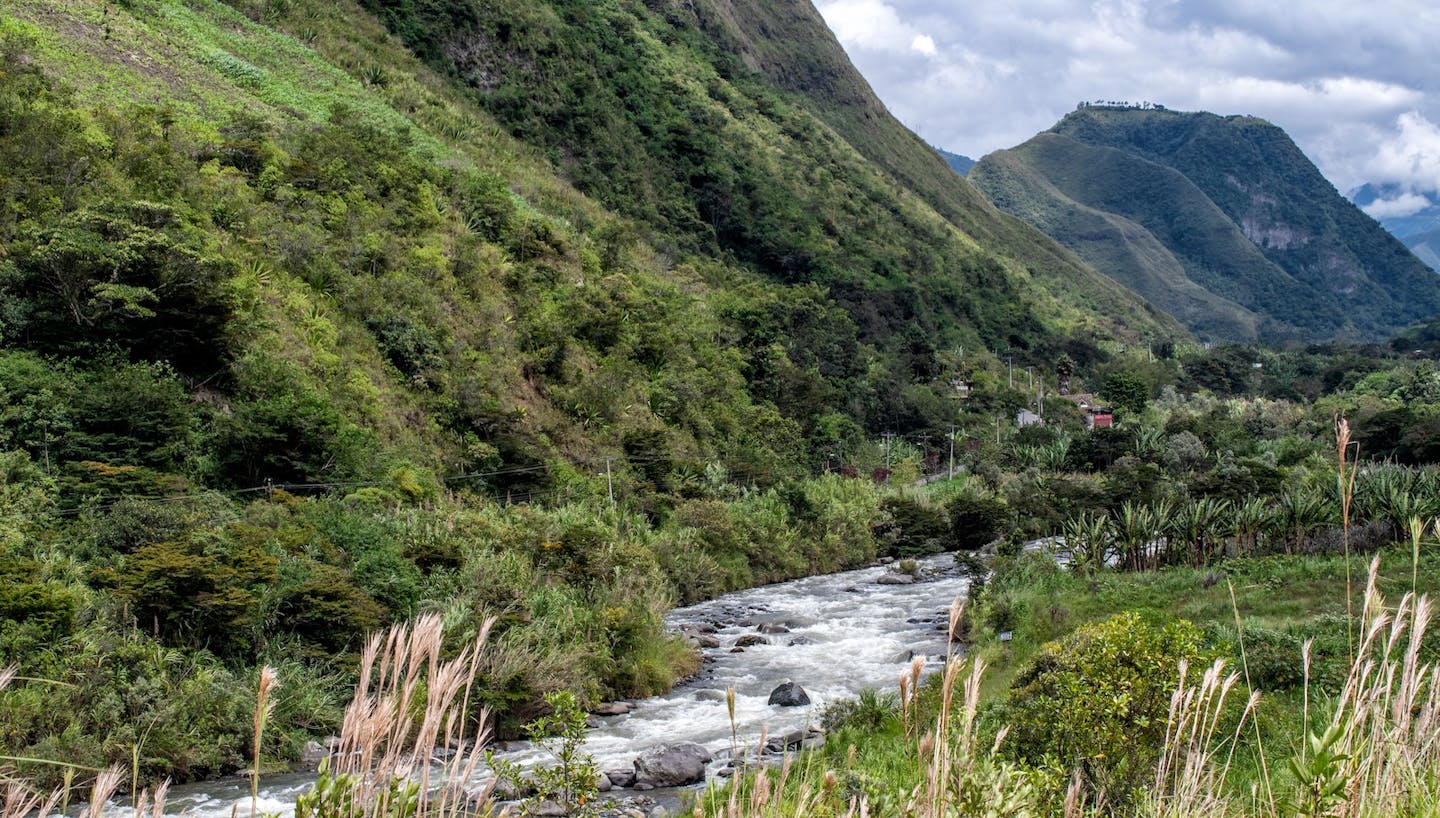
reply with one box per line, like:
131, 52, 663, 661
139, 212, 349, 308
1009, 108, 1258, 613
969, 107, 1440, 340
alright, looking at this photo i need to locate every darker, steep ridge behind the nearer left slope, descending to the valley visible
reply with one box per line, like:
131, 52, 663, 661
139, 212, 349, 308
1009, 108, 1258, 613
351, 0, 1174, 349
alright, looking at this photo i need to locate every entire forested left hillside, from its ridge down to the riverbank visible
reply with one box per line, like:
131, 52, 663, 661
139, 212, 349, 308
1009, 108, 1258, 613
0, 0, 1184, 779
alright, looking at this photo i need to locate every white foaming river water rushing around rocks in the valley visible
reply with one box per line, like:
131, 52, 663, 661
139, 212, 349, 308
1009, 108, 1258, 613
146, 554, 969, 818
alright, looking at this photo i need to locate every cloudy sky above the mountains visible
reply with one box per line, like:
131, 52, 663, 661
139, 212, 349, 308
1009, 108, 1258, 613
815, 0, 1440, 216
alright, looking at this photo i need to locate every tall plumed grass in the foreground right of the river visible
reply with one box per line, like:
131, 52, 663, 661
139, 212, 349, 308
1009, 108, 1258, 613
714, 559, 1440, 818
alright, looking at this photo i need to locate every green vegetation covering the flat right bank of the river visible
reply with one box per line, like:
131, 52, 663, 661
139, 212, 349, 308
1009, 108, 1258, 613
707, 345, 1440, 815
